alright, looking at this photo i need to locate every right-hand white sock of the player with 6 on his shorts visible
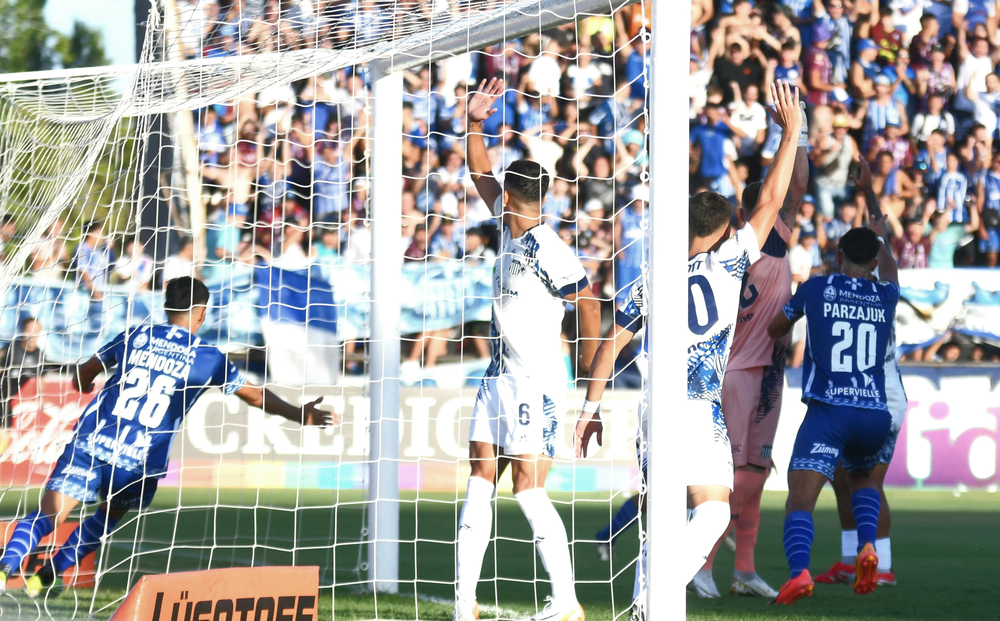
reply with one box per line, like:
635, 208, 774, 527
514, 487, 577, 608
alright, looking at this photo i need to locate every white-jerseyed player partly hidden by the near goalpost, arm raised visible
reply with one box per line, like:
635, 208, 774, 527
577, 82, 802, 584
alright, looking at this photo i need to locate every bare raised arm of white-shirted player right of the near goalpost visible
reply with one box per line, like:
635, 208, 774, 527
750, 82, 802, 248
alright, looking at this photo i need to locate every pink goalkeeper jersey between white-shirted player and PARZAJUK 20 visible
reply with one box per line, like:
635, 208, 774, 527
726, 220, 792, 371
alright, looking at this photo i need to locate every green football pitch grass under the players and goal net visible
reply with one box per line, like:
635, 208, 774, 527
0, 488, 1000, 621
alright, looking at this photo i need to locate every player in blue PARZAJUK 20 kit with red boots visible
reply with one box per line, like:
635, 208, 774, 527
768, 216, 899, 604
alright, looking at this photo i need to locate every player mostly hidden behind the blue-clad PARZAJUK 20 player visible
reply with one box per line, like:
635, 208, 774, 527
816, 154, 908, 586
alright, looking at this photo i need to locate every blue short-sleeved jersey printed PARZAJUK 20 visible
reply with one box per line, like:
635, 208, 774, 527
783, 274, 899, 411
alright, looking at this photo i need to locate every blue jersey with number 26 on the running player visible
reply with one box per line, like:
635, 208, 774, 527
73, 325, 246, 476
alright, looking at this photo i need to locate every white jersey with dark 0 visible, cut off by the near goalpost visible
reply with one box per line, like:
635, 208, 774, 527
687, 223, 760, 408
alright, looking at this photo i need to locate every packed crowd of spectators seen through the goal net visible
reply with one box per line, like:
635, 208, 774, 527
0, 0, 651, 378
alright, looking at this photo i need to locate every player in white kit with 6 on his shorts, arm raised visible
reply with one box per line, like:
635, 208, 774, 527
453, 79, 601, 621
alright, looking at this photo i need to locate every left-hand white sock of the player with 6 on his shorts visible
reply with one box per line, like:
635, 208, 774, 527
455, 477, 494, 602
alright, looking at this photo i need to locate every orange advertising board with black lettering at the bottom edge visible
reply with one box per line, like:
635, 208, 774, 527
111, 566, 319, 621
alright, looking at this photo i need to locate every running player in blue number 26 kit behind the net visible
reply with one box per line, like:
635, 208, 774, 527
0, 277, 340, 598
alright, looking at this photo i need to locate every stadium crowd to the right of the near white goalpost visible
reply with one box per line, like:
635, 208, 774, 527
689, 0, 1000, 364
